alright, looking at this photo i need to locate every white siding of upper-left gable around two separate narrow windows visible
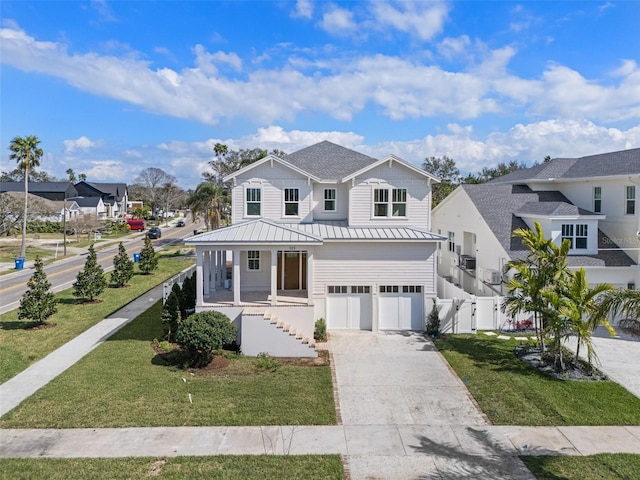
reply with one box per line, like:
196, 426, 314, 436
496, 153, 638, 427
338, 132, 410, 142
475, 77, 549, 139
232, 162, 312, 223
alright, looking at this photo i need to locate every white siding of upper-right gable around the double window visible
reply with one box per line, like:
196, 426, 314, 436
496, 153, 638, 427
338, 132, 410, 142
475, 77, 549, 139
349, 163, 431, 229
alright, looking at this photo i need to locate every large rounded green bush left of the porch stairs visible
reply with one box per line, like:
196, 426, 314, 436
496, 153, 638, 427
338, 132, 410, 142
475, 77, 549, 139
176, 311, 237, 367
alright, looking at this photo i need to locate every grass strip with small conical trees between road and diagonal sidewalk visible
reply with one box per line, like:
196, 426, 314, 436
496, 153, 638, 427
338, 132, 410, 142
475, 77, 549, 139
0, 259, 193, 383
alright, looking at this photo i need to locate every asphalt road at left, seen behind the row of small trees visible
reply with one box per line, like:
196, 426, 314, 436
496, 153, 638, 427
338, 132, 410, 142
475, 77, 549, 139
0, 222, 202, 314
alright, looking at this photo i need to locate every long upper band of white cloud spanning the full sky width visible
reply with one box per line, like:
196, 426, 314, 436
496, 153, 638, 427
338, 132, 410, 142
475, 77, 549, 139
0, 25, 640, 132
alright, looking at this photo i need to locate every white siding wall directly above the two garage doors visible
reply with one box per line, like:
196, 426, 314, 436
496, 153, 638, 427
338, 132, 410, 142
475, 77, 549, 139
313, 242, 436, 298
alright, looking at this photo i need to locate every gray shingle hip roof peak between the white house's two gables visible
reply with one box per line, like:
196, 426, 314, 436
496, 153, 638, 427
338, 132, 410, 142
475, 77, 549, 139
284, 140, 378, 180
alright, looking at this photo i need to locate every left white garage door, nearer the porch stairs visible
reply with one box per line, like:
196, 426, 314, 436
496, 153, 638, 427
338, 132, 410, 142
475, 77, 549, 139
327, 285, 373, 330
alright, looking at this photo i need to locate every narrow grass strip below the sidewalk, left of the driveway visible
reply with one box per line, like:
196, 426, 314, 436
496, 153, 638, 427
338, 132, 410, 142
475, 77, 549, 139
0, 455, 344, 480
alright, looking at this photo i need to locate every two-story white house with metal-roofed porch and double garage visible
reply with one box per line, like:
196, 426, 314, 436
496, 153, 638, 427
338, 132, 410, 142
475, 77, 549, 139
187, 141, 444, 356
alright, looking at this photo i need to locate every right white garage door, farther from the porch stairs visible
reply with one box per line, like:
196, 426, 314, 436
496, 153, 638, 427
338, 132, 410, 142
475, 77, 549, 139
378, 285, 425, 330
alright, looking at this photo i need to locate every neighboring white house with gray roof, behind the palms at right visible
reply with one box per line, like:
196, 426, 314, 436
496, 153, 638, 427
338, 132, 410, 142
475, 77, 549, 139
433, 149, 640, 295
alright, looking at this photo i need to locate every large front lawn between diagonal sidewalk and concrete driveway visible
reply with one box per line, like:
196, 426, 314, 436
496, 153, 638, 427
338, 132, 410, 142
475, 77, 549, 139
0, 302, 336, 428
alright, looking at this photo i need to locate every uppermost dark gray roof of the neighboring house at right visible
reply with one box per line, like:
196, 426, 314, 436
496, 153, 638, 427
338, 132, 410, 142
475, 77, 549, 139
488, 148, 640, 184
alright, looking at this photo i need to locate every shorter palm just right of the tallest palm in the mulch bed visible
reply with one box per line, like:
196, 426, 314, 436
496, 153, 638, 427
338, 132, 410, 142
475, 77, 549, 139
560, 268, 615, 364
